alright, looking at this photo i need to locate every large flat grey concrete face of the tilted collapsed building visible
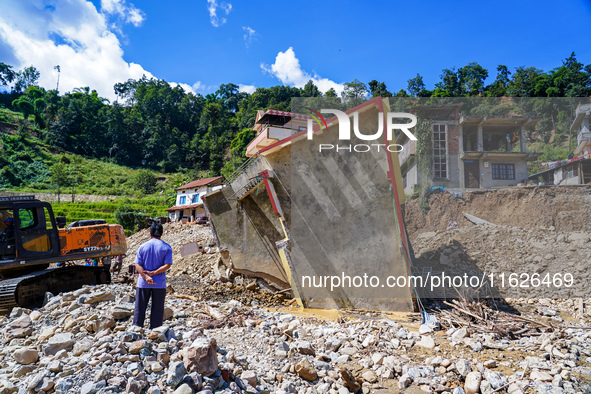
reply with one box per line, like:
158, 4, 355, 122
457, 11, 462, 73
290, 104, 412, 310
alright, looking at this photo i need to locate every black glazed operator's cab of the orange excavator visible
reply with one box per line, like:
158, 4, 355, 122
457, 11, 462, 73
0, 196, 60, 268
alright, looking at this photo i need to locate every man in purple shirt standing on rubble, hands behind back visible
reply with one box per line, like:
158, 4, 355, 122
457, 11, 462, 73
133, 222, 172, 329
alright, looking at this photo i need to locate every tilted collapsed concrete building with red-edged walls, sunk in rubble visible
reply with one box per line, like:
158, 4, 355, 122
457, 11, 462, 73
204, 97, 415, 311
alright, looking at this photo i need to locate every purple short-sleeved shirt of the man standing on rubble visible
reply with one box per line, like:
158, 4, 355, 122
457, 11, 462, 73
135, 238, 172, 289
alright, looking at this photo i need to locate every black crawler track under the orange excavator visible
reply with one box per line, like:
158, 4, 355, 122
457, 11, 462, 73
0, 265, 111, 310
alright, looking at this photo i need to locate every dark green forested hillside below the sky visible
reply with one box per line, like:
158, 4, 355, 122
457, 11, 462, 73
0, 53, 591, 185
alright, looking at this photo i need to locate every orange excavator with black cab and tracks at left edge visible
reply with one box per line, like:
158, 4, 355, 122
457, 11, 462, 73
0, 196, 127, 310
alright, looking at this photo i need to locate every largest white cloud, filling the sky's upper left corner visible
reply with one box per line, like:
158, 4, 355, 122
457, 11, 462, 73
0, 0, 192, 101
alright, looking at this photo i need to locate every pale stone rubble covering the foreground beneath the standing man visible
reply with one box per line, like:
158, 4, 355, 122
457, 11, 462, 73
0, 284, 591, 394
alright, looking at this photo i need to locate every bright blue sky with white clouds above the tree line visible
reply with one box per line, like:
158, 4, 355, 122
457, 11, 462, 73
0, 0, 591, 98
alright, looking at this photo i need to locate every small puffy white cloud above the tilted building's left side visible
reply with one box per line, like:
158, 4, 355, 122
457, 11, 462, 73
261, 47, 344, 95
